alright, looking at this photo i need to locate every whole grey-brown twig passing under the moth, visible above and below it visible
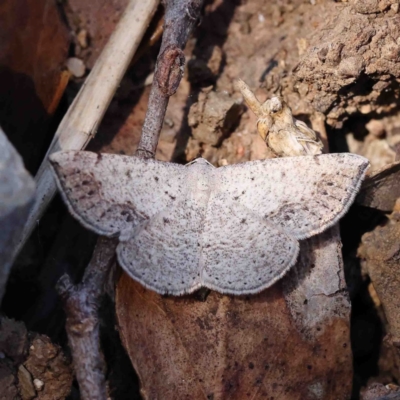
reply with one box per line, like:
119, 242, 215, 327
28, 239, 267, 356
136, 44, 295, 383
58, 0, 203, 400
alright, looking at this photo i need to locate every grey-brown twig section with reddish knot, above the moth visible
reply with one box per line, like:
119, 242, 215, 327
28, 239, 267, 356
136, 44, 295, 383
136, 0, 203, 158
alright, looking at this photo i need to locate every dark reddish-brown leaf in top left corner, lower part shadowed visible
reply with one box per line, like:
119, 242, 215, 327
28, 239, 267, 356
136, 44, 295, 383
0, 0, 69, 170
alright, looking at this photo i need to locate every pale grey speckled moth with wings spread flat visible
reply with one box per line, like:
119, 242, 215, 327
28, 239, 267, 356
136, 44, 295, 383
50, 151, 368, 295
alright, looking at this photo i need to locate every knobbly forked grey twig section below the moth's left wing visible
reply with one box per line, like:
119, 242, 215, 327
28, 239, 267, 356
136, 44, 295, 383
57, 237, 117, 400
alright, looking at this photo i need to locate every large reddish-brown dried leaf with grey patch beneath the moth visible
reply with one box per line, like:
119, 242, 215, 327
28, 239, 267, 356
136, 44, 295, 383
116, 228, 352, 400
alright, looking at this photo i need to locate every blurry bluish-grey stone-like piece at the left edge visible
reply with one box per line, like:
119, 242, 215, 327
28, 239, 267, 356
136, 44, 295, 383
0, 128, 35, 304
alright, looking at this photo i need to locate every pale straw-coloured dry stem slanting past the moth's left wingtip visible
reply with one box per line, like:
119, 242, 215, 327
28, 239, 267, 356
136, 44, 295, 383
13, 0, 159, 255
